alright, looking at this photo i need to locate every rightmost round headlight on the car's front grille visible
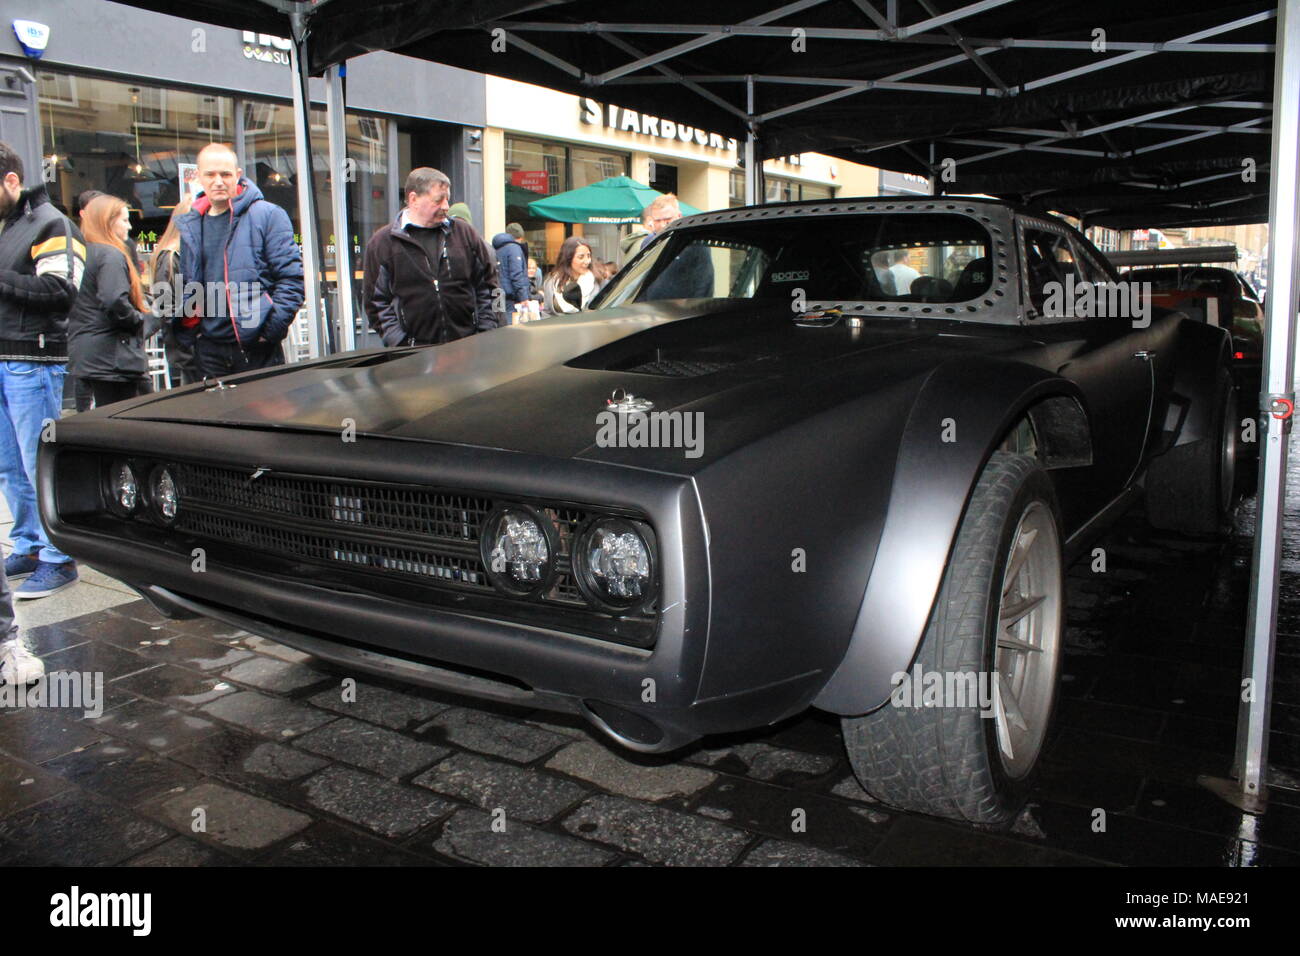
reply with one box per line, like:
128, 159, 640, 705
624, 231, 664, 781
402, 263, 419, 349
573, 518, 654, 611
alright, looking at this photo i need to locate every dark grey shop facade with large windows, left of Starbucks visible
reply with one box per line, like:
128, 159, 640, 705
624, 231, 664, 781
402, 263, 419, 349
0, 0, 485, 351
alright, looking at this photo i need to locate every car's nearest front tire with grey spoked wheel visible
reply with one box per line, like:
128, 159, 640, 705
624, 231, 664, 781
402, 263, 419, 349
841, 451, 1065, 826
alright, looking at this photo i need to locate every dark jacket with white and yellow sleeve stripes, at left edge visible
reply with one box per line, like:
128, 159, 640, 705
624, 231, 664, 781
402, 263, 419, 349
0, 185, 86, 364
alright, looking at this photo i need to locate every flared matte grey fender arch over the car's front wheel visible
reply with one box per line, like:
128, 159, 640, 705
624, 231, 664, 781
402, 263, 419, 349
813, 356, 1088, 715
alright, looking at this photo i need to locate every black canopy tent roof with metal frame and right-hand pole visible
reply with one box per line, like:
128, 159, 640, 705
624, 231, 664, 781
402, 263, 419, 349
104, 0, 1300, 809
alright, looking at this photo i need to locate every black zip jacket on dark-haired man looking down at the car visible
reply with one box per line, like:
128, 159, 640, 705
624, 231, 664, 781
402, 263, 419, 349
363, 213, 504, 346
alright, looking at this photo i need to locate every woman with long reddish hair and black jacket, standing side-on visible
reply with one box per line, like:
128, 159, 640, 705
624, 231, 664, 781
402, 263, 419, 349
68, 196, 151, 407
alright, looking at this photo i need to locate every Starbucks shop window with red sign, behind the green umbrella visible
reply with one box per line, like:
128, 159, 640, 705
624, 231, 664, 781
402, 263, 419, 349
504, 137, 628, 268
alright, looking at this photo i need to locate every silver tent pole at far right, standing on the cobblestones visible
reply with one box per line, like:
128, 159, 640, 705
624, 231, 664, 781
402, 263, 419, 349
1205, 0, 1300, 813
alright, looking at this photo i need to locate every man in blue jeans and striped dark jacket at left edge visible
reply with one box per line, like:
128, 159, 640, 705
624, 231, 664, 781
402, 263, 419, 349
0, 143, 86, 598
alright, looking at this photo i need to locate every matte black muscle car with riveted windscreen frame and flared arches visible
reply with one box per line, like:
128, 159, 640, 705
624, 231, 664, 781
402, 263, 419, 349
40, 198, 1236, 823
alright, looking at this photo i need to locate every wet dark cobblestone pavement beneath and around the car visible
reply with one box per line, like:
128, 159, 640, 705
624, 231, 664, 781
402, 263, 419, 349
0, 478, 1300, 866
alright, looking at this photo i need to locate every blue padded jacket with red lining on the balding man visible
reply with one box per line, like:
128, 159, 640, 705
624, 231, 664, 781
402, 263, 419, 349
177, 177, 306, 346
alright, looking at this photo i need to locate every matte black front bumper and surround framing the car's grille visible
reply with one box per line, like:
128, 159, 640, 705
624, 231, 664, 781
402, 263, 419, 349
39, 419, 815, 752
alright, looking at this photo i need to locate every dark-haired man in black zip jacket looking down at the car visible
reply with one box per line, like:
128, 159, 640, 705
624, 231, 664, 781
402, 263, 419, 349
364, 166, 504, 346
